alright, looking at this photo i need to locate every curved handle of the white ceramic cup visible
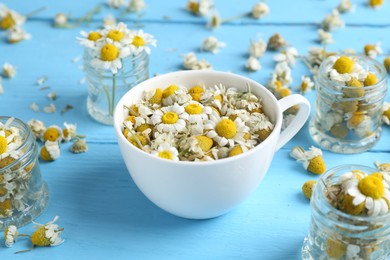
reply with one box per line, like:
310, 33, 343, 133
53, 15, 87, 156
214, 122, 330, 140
276, 94, 310, 151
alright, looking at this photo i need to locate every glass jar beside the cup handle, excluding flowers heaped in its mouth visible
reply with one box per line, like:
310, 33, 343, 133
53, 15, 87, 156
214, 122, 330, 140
309, 56, 387, 153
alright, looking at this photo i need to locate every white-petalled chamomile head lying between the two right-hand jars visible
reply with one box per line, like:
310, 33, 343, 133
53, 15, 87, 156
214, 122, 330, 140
290, 146, 326, 174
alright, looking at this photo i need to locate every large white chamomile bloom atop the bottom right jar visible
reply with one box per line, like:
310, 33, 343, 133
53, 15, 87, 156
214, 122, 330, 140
342, 173, 390, 216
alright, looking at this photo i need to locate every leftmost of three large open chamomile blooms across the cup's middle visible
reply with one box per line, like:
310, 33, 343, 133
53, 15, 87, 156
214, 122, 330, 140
151, 103, 188, 133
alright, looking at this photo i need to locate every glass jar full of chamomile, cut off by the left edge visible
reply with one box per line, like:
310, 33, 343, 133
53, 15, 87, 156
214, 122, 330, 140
0, 117, 49, 230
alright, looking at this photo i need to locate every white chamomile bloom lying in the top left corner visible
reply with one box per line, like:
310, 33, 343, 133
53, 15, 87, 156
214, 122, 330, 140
0, 3, 31, 43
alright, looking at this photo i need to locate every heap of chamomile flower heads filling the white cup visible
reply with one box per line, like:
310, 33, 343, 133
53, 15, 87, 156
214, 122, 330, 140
123, 84, 274, 161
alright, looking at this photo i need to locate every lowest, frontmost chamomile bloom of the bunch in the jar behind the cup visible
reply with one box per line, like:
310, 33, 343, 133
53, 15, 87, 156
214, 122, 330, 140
91, 38, 131, 74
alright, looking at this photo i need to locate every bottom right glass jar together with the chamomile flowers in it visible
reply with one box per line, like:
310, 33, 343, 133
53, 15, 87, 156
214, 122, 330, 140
302, 165, 390, 260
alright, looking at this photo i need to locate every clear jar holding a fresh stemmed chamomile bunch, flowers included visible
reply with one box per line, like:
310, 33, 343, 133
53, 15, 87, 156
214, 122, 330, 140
78, 23, 156, 125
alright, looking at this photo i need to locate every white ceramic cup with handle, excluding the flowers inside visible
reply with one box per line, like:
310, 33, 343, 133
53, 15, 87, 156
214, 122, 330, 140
114, 71, 310, 219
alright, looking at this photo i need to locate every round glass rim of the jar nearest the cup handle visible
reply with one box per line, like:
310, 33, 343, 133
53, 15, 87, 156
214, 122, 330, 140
317, 54, 387, 90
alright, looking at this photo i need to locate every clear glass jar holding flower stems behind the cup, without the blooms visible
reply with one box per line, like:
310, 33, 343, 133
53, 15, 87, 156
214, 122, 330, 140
83, 49, 149, 125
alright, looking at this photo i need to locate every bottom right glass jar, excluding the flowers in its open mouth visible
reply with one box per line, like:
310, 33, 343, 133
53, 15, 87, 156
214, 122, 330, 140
302, 165, 390, 260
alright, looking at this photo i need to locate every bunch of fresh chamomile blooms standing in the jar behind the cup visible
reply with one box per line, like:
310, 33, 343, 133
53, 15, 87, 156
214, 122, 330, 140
77, 23, 156, 74
